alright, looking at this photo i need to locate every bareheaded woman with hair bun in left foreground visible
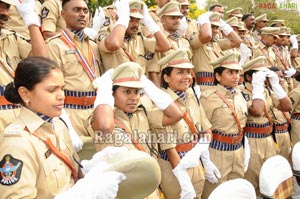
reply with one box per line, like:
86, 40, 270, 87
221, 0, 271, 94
0, 58, 78, 199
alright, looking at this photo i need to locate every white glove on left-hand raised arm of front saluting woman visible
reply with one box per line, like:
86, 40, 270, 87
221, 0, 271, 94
94, 68, 115, 109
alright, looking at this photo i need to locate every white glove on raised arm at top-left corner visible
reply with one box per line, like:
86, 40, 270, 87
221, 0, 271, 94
14, 0, 41, 27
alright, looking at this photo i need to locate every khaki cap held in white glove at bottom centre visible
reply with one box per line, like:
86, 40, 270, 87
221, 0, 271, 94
107, 150, 161, 199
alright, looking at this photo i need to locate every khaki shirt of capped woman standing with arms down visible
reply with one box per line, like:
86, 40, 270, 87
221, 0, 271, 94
201, 84, 248, 134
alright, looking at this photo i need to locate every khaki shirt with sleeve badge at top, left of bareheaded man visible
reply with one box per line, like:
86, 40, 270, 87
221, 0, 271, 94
41, 0, 66, 32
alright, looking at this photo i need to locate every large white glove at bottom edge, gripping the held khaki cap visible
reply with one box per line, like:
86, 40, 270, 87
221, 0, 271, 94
54, 163, 126, 199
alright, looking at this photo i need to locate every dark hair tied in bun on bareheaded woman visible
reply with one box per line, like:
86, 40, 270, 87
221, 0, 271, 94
4, 57, 59, 104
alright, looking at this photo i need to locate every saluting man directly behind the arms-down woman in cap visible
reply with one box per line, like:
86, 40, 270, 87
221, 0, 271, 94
190, 13, 241, 90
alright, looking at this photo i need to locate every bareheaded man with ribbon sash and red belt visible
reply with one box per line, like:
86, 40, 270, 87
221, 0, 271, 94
47, 0, 103, 159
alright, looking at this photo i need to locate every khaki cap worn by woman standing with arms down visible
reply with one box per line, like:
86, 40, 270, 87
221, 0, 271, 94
209, 52, 242, 70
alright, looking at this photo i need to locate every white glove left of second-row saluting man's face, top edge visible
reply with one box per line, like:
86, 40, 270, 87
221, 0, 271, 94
114, 0, 130, 29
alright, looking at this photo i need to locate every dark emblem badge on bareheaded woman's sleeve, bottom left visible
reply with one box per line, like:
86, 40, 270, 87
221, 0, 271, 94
0, 154, 23, 186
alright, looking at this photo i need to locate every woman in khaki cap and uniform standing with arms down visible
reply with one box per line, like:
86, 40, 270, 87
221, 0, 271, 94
201, 52, 249, 198
